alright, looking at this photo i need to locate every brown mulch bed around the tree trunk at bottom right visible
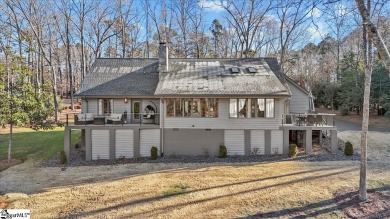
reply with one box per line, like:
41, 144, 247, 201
334, 187, 390, 218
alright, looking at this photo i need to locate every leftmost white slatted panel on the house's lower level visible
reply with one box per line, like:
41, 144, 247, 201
92, 130, 110, 160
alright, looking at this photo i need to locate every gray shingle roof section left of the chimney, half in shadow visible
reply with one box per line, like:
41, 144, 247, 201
76, 58, 158, 96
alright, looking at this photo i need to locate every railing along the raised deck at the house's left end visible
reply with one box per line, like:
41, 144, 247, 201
66, 113, 160, 126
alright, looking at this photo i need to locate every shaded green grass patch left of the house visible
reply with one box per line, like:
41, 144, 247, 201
0, 128, 80, 162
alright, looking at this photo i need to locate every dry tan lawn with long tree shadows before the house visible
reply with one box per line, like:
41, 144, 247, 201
0, 129, 390, 218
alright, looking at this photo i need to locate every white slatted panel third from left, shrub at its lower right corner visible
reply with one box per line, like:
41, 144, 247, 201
139, 129, 160, 157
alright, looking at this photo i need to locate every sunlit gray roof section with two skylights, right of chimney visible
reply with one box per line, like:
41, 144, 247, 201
155, 58, 290, 96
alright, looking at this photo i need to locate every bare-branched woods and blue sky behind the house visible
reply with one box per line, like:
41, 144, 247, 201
0, 0, 390, 120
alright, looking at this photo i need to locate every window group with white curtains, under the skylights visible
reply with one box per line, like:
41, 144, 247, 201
229, 99, 275, 118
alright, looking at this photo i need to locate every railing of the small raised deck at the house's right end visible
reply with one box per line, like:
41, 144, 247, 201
282, 113, 335, 126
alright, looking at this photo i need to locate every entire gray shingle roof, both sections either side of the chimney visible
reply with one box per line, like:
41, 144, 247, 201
76, 58, 290, 96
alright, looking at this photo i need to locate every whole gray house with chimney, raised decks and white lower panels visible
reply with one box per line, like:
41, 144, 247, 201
64, 43, 337, 160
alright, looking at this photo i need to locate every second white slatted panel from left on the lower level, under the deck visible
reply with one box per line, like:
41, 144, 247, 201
115, 129, 134, 158
